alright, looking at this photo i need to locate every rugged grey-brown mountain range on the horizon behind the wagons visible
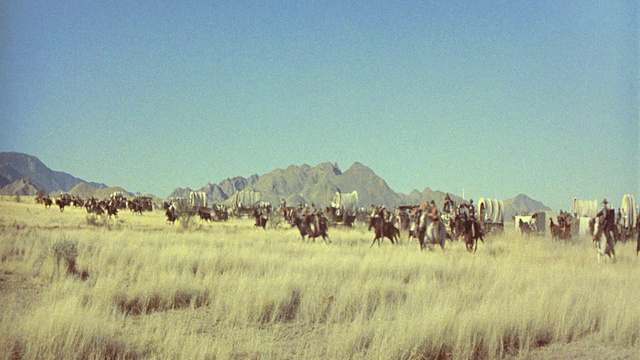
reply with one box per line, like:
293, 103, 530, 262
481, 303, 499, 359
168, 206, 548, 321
0, 152, 551, 219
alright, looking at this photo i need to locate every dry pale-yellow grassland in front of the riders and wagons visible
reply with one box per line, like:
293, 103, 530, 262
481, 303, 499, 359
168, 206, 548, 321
0, 197, 640, 359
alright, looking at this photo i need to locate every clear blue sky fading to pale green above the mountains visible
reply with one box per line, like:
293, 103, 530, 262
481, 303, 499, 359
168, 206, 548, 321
0, 0, 640, 210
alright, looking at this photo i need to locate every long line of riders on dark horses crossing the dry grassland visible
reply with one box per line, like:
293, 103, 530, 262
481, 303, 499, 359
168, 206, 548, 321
36, 192, 640, 258
